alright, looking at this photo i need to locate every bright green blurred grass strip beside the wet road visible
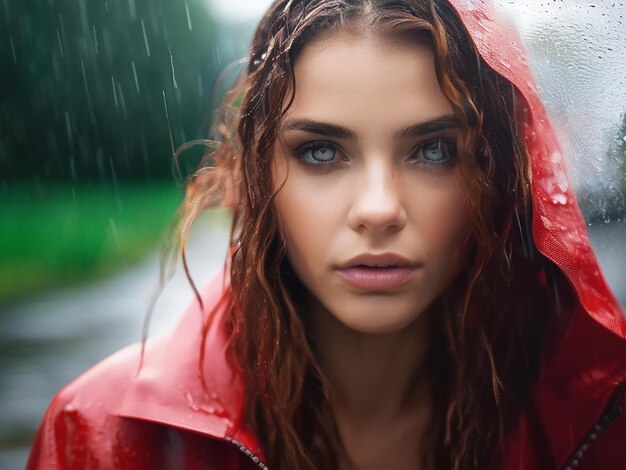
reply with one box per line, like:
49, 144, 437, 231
0, 183, 182, 304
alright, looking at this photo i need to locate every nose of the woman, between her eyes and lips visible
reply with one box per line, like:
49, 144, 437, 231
348, 164, 407, 234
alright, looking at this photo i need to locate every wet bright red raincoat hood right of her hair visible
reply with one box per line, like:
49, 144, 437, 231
450, 0, 626, 338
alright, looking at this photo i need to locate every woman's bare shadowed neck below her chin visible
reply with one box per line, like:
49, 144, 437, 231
310, 305, 431, 427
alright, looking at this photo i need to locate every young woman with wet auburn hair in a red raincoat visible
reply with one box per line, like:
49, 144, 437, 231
29, 0, 626, 469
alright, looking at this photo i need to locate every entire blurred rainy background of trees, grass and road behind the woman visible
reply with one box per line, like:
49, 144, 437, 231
0, 0, 626, 469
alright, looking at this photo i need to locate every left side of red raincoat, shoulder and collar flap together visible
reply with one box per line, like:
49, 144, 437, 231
27, 274, 261, 470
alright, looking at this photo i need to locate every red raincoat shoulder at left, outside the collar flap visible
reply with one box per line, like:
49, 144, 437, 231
26, 352, 258, 470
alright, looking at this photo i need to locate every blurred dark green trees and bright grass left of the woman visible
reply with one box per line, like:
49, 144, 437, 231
0, 0, 252, 304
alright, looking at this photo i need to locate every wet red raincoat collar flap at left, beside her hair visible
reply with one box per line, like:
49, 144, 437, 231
118, 271, 265, 468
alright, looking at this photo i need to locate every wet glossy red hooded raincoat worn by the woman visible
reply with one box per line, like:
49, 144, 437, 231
27, 0, 626, 470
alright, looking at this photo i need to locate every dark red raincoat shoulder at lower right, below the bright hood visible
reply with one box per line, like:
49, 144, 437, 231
499, 305, 626, 470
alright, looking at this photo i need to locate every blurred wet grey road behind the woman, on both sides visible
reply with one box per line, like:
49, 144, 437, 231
0, 223, 626, 469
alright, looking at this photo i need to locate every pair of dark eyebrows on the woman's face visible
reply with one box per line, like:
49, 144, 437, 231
282, 115, 460, 140
